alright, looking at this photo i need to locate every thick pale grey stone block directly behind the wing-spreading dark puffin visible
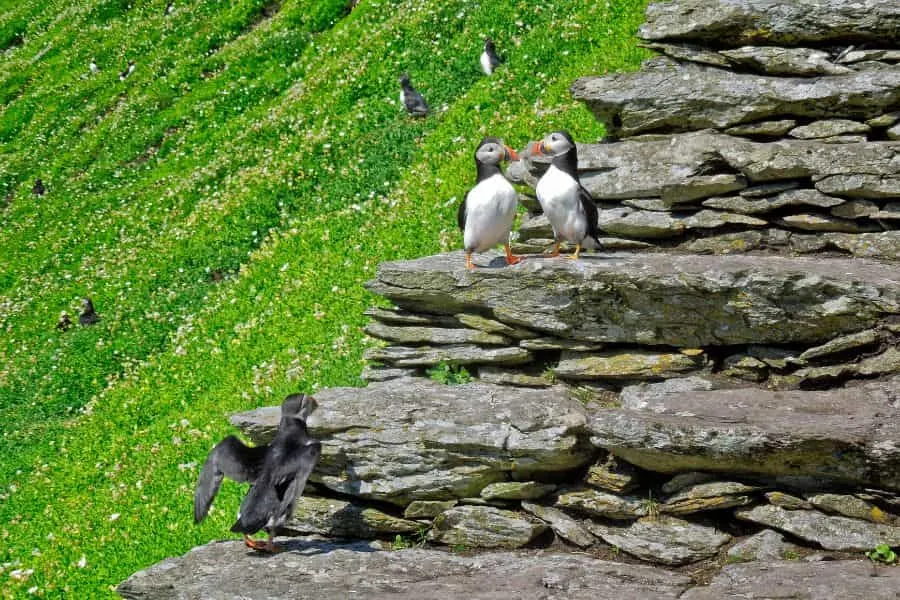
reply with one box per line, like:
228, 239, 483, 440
232, 379, 594, 505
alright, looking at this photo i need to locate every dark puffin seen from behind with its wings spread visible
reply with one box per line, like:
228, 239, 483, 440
194, 394, 322, 553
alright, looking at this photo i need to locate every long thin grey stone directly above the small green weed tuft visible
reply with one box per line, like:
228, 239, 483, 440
363, 344, 531, 367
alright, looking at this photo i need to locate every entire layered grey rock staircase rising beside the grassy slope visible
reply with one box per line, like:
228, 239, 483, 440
120, 0, 900, 600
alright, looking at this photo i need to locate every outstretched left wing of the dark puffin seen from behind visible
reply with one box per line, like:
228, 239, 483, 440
194, 435, 268, 523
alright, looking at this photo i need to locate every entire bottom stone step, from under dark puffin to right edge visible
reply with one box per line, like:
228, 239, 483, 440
117, 538, 900, 600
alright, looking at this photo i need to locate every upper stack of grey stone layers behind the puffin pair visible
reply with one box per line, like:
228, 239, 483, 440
512, 0, 900, 259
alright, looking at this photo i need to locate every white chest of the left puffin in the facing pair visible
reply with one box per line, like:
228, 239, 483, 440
463, 173, 517, 252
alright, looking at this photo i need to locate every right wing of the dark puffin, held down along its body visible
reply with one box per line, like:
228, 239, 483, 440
231, 441, 322, 533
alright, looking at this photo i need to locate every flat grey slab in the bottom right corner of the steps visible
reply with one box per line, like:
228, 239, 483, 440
681, 560, 900, 600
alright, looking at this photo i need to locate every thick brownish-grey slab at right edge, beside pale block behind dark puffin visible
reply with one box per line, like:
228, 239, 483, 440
590, 378, 900, 490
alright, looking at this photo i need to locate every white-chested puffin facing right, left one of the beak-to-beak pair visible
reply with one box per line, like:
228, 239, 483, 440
456, 137, 522, 269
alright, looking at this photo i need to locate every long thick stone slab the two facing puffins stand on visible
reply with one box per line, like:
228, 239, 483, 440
367, 251, 900, 348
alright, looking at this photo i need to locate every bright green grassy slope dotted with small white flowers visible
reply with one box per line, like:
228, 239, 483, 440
0, 0, 643, 597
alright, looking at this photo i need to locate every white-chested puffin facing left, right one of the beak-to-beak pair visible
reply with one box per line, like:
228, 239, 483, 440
533, 131, 601, 259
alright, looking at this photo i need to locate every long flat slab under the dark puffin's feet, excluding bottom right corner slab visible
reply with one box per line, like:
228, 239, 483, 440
117, 539, 690, 600
